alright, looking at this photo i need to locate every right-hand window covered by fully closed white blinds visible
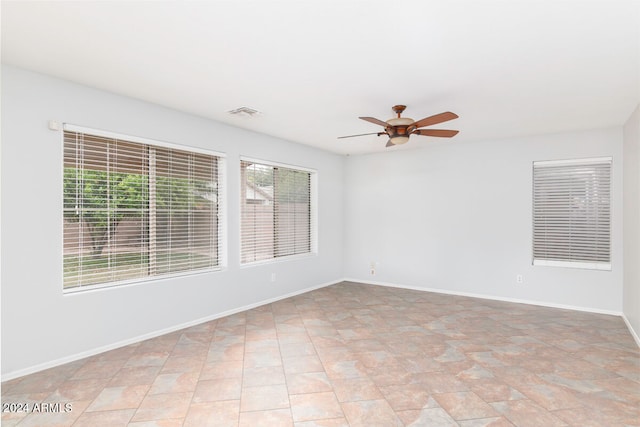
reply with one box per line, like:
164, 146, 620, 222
533, 158, 611, 270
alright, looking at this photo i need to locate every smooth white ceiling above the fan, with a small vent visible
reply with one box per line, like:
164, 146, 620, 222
1, 0, 640, 154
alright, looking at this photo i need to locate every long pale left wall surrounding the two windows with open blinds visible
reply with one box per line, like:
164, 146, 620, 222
1, 67, 344, 380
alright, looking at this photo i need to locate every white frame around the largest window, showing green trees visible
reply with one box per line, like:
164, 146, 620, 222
60, 123, 227, 294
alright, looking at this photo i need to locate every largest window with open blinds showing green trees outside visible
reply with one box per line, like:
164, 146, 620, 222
63, 125, 222, 289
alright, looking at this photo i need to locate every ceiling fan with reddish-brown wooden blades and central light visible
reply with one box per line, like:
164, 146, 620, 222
338, 105, 458, 147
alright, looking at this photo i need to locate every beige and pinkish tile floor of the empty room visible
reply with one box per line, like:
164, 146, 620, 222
2, 282, 640, 427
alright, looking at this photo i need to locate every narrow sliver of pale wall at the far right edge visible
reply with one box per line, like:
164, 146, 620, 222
623, 105, 640, 345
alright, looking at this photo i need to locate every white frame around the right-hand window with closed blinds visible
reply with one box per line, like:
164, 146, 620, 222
531, 156, 614, 271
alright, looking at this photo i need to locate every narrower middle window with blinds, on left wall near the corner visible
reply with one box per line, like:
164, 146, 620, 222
241, 160, 314, 264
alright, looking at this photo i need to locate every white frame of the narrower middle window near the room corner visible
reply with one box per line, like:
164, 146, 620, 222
238, 155, 318, 268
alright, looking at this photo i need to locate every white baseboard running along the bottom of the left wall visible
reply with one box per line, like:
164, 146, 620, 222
2, 280, 342, 382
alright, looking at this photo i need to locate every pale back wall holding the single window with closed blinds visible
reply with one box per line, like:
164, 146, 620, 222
345, 129, 622, 313
